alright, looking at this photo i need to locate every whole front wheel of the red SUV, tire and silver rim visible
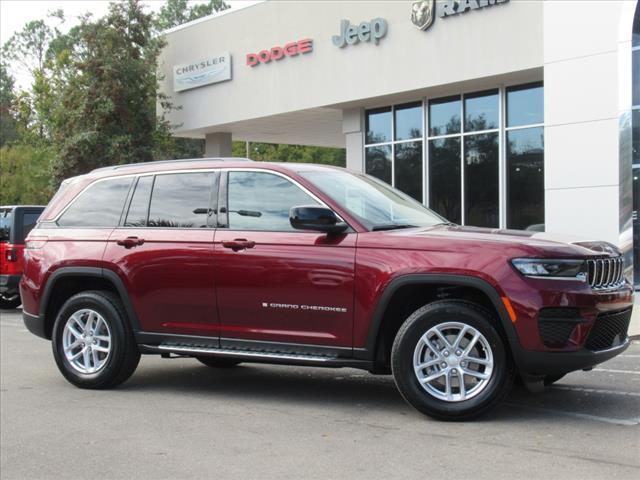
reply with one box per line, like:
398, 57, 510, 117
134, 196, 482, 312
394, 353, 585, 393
391, 300, 515, 420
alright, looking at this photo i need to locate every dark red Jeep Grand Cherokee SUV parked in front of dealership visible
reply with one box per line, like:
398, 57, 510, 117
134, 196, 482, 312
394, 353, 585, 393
20, 159, 633, 419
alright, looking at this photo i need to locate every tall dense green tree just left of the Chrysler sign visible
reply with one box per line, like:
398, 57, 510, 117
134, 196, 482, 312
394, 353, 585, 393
52, 0, 164, 183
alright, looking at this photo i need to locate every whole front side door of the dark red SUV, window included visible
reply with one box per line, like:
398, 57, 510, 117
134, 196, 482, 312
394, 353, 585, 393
214, 170, 356, 347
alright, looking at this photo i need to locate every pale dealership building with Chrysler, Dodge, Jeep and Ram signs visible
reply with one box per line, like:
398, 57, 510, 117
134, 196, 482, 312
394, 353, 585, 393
161, 0, 640, 278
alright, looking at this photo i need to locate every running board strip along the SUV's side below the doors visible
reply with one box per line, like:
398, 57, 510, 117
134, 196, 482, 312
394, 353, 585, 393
139, 344, 371, 370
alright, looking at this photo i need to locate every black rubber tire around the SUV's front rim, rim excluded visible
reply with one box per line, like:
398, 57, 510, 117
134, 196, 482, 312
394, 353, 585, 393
391, 300, 515, 420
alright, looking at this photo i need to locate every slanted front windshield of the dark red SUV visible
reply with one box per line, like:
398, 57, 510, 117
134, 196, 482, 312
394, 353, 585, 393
299, 170, 448, 230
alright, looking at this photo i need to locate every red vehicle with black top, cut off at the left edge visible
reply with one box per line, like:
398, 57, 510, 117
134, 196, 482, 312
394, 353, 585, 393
0, 205, 44, 309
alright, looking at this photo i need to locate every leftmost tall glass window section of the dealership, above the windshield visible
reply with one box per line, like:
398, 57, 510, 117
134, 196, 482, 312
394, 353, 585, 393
365, 102, 423, 202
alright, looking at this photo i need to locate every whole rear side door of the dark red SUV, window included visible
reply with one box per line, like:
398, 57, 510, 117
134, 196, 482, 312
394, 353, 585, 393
104, 171, 219, 345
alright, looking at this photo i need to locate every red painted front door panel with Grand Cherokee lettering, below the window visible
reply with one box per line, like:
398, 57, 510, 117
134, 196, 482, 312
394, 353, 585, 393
215, 229, 356, 347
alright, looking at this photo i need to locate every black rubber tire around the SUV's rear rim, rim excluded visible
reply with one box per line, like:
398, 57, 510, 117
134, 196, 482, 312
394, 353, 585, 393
51, 291, 140, 389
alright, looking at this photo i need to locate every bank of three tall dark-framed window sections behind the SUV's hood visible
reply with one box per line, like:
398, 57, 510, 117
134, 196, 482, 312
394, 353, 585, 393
365, 82, 544, 230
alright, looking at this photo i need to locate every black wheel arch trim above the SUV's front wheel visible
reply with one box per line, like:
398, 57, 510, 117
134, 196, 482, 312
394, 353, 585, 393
354, 274, 522, 358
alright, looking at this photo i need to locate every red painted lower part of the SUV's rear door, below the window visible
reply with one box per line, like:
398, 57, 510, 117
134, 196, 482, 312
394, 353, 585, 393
102, 228, 219, 336
